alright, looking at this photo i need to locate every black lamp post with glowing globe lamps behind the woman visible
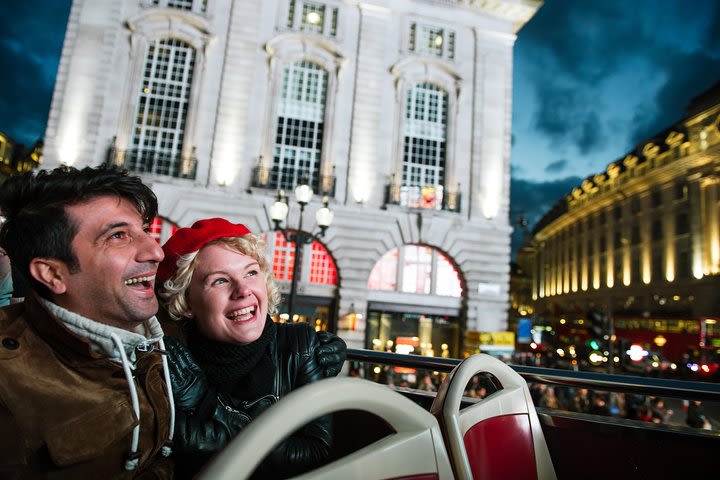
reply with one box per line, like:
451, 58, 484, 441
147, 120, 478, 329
270, 183, 335, 321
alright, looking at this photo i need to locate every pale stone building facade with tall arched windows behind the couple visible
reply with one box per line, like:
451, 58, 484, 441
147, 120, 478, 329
45, 0, 540, 355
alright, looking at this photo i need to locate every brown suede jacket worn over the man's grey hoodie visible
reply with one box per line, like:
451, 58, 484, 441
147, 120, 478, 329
0, 293, 173, 479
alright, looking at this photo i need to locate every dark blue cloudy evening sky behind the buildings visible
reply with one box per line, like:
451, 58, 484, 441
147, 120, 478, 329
0, 0, 720, 256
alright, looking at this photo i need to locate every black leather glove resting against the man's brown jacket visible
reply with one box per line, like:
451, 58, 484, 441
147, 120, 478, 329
164, 337, 209, 411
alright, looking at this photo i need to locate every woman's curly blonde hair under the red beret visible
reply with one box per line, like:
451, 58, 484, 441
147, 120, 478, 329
158, 234, 280, 320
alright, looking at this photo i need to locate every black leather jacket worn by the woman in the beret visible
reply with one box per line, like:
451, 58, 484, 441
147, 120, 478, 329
175, 323, 331, 478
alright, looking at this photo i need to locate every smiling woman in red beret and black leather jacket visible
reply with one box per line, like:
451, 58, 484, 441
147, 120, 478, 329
157, 218, 337, 478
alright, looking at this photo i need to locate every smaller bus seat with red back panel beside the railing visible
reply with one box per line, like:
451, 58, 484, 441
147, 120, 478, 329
430, 354, 556, 480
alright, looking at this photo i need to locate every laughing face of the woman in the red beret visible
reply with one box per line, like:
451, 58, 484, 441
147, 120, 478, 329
188, 244, 268, 345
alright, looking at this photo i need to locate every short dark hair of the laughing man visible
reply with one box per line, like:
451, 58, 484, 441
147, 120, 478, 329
0, 166, 157, 298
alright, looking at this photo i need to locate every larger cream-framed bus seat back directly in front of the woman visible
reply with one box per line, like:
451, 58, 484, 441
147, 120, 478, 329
199, 378, 454, 480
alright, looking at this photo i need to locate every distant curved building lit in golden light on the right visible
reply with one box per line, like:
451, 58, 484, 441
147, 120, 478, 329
532, 83, 720, 362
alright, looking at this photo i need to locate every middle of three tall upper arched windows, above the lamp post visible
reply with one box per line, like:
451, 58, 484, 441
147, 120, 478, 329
270, 60, 328, 191
